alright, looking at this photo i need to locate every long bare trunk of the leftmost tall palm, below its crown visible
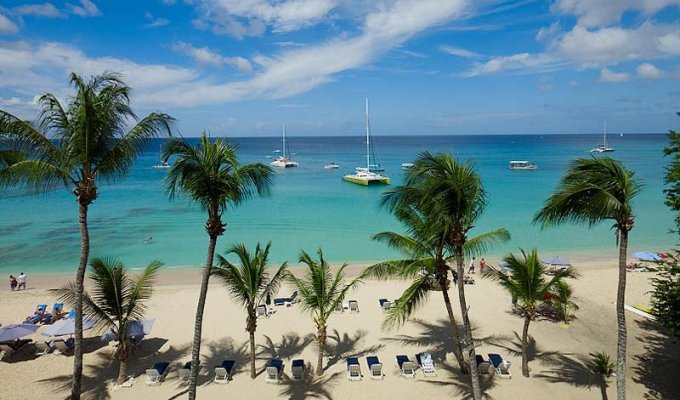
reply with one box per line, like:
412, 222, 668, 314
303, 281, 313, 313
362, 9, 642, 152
71, 202, 90, 400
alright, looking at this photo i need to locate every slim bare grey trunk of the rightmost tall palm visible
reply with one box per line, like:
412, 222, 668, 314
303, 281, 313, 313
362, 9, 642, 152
616, 229, 628, 400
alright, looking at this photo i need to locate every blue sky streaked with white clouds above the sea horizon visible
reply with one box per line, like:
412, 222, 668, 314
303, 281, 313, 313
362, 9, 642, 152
0, 0, 680, 136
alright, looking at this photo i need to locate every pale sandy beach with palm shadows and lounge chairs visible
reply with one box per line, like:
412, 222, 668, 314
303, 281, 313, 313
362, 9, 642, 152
0, 260, 680, 399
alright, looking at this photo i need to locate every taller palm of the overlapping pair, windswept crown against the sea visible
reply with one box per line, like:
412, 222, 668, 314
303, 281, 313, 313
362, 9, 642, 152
382, 151, 510, 400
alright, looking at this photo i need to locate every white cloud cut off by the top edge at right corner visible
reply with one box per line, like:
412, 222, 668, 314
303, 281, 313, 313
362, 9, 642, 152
551, 0, 680, 28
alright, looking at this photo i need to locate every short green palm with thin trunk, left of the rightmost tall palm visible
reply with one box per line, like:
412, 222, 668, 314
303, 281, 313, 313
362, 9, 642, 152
494, 249, 569, 377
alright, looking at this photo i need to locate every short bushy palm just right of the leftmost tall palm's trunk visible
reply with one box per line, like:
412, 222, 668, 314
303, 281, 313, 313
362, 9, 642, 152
57, 258, 163, 385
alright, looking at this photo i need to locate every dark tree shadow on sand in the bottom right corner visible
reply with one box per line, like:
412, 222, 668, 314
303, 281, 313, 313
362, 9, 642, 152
629, 320, 680, 400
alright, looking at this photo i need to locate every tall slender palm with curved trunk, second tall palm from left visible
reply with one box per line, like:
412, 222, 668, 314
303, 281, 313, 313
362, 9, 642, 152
163, 132, 273, 400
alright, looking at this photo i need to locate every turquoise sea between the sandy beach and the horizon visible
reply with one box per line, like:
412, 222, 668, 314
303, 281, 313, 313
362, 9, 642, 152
0, 134, 676, 274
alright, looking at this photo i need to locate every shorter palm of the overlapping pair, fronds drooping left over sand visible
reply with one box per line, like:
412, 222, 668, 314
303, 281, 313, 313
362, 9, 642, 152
364, 199, 506, 374
